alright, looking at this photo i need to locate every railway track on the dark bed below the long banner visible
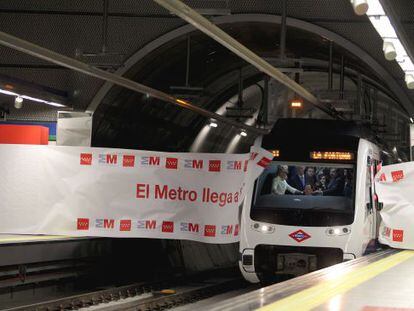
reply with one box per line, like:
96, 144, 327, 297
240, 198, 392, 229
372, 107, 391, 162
6, 277, 249, 311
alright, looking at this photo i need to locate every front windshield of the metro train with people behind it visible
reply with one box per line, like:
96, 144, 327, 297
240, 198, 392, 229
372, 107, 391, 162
251, 161, 355, 227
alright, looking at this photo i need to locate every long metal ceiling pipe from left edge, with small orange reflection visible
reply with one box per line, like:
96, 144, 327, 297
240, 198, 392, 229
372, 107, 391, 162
0, 31, 268, 135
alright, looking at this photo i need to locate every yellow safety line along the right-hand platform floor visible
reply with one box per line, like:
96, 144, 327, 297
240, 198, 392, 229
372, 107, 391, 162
257, 251, 414, 311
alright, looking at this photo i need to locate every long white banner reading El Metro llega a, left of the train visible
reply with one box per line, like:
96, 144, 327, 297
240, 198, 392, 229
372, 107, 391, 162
0, 145, 271, 243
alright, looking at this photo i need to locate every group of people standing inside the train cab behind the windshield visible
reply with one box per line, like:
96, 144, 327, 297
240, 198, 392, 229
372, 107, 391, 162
271, 165, 353, 197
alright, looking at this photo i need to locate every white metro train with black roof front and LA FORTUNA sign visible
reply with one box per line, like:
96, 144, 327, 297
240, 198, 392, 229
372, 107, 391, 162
239, 119, 392, 283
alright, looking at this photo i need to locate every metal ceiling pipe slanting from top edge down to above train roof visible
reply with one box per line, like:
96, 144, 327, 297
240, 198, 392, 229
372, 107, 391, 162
153, 0, 343, 119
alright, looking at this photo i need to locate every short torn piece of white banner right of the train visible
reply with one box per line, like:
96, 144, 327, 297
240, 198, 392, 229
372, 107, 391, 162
375, 162, 414, 249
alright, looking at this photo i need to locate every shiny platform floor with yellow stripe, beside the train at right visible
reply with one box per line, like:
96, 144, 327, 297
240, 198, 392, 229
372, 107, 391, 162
209, 250, 414, 311
